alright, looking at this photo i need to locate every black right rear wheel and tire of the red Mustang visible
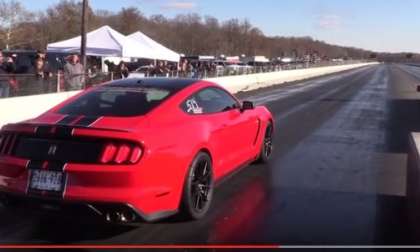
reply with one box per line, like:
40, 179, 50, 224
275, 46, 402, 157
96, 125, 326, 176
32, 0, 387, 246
181, 152, 214, 220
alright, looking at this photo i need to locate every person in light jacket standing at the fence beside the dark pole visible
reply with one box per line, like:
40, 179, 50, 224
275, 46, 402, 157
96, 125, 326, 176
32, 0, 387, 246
64, 55, 85, 91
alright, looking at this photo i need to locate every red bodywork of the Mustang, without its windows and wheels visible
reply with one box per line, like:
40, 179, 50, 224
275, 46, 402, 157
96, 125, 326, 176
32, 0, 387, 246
0, 79, 273, 221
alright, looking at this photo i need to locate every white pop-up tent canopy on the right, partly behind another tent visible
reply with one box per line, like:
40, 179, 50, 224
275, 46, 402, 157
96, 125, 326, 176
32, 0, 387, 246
128, 32, 180, 62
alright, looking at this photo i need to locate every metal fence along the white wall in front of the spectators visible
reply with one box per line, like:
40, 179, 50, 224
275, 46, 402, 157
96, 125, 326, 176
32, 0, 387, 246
0, 61, 368, 98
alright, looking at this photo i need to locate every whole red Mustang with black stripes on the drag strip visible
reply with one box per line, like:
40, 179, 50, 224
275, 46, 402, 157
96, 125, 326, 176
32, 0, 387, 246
0, 79, 274, 223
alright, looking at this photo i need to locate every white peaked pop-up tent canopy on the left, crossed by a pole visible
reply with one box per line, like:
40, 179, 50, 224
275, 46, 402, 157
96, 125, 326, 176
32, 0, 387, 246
47, 26, 156, 59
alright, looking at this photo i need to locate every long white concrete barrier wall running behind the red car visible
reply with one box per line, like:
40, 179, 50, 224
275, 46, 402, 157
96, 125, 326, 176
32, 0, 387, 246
0, 63, 375, 127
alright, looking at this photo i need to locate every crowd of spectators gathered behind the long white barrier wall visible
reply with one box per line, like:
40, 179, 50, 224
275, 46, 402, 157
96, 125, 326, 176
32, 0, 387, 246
0, 47, 354, 98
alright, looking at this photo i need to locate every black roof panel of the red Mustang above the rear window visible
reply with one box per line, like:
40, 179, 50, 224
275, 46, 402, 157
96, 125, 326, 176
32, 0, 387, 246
105, 78, 200, 92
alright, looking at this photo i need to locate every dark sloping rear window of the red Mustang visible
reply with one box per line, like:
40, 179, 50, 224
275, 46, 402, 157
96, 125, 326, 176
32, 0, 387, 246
58, 86, 173, 117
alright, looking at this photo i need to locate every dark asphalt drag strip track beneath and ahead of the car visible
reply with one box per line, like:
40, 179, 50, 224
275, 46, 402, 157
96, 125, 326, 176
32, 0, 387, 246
0, 64, 420, 248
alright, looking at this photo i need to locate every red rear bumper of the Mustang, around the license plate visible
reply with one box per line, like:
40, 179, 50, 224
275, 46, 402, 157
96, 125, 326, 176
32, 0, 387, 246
0, 158, 179, 222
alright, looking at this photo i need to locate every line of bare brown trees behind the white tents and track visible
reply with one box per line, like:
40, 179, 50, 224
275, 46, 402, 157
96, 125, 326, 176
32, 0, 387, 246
0, 0, 416, 59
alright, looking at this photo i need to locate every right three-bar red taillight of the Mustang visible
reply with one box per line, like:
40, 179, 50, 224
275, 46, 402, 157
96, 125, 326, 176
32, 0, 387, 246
100, 143, 143, 165
